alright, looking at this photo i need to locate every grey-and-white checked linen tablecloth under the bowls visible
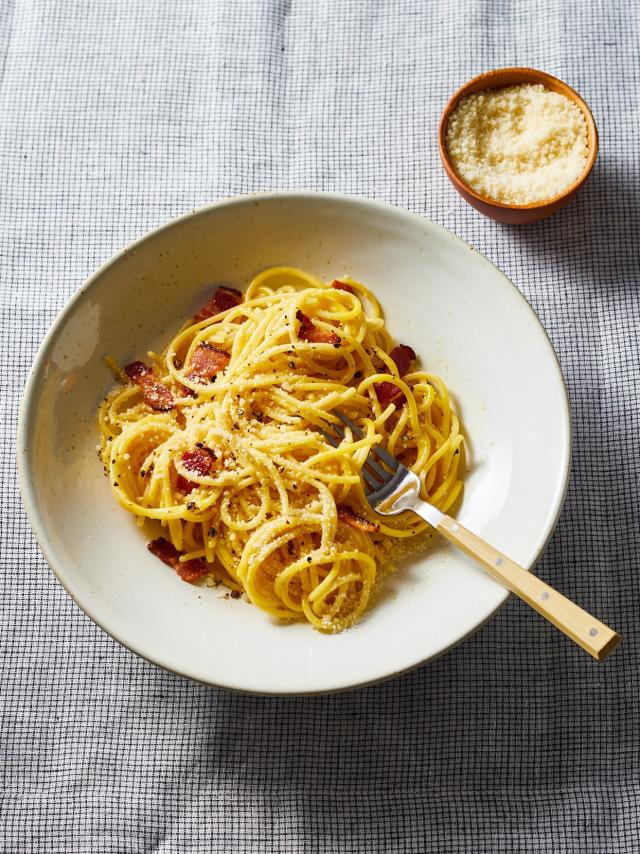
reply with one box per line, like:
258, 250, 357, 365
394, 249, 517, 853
0, 0, 640, 854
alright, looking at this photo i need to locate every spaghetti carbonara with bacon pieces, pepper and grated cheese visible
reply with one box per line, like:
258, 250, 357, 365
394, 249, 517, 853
99, 267, 463, 631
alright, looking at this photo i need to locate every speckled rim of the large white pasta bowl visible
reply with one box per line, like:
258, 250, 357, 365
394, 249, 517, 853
16, 189, 573, 697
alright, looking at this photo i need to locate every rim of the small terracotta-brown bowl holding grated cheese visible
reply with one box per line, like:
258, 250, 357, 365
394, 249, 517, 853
438, 65, 599, 211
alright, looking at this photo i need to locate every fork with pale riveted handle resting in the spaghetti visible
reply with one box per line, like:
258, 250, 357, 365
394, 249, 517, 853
318, 410, 621, 661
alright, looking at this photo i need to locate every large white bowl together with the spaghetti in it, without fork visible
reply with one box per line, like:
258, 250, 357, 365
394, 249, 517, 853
17, 192, 570, 694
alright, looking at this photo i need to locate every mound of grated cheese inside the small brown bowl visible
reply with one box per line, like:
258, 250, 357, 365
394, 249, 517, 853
446, 83, 587, 205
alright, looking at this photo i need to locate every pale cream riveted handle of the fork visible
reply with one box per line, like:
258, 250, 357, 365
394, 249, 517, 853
432, 507, 621, 661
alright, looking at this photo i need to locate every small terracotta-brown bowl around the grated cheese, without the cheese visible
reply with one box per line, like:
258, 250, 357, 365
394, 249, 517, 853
438, 68, 598, 225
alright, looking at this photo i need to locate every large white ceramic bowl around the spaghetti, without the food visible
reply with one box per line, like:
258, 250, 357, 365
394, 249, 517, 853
18, 192, 570, 694
